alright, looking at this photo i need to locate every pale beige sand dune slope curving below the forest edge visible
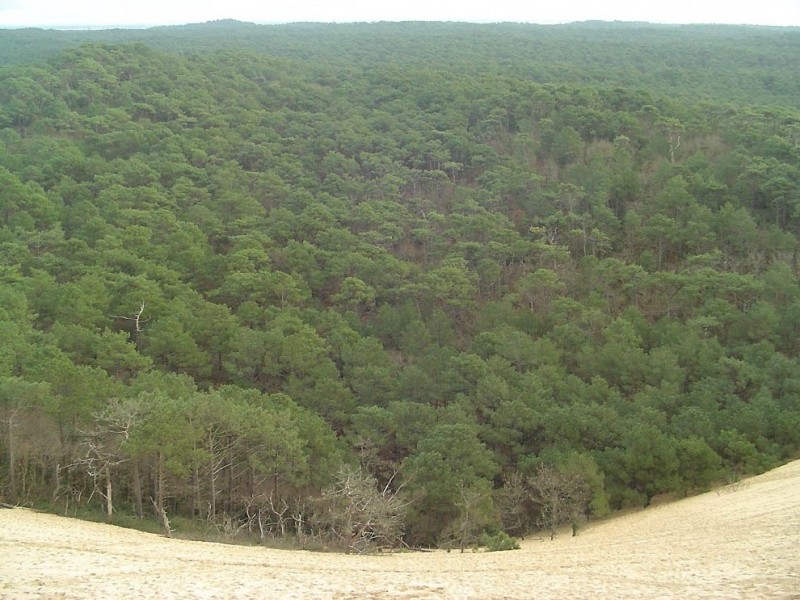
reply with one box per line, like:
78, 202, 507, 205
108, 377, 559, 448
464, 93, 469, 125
0, 461, 800, 600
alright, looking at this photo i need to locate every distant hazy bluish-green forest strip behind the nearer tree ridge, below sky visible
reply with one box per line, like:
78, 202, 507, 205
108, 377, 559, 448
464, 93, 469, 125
0, 21, 800, 107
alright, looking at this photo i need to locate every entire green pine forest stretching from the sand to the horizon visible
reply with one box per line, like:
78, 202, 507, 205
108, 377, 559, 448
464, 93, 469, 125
0, 22, 800, 550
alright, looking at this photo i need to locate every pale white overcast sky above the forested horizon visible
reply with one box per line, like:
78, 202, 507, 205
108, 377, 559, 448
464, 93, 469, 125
0, 0, 800, 28
